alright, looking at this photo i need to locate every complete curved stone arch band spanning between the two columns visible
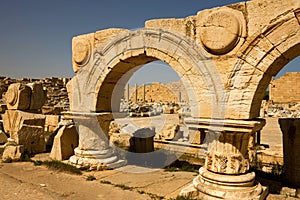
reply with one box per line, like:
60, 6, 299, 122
69, 28, 223, 117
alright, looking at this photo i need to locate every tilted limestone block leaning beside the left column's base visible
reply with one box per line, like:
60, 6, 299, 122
50, 125, 78, 160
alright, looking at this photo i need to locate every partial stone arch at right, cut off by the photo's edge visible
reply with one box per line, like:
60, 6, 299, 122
226, 9, 300, 119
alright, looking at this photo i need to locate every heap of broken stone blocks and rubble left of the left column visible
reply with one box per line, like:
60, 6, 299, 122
0, 78, 72, 160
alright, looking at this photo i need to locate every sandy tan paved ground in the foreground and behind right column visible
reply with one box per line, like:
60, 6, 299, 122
0, 115, 295, 200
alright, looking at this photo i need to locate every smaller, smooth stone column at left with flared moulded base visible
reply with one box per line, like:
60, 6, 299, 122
65, 112, 126, 170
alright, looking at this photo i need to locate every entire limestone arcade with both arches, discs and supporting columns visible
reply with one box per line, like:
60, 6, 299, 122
67, 0, 300, 199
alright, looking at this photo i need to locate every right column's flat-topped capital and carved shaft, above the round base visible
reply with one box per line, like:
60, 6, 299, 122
185, 118, 265, 174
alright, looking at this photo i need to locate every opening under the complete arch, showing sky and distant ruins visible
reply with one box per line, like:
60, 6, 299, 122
103, 56, 193, 168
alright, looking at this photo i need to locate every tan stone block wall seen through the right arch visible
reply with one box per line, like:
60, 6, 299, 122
270, 72, 300, 103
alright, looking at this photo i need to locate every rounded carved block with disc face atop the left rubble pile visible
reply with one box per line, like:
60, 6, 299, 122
5, 83, 31, 110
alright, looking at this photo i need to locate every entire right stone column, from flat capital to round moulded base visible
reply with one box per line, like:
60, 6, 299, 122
180, 118, 267, 199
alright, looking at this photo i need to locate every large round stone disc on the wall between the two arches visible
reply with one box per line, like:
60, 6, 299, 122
200, 11, 241, 54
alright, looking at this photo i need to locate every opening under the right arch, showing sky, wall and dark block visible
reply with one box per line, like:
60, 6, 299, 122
257, 56, 300, 188
